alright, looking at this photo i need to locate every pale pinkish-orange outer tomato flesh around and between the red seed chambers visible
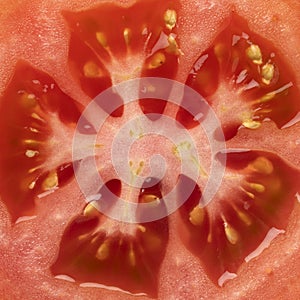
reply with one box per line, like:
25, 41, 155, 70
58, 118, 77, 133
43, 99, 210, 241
0, 1, 300, 299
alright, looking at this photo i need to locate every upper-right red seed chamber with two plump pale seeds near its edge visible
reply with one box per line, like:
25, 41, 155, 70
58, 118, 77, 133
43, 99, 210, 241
177, 13, 300, 140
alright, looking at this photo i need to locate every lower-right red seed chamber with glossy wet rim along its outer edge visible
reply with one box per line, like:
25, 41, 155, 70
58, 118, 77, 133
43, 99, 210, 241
178, 150, 300, 285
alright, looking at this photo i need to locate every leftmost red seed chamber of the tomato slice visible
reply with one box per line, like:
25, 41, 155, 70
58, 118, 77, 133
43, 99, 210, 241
0, 62, 80, 220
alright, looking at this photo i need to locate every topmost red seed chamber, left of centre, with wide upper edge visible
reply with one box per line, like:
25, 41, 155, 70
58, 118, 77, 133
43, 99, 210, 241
65, 1, 179, 118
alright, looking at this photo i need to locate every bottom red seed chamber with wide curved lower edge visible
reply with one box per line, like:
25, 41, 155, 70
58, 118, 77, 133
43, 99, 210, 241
51, 178, 169, 296
